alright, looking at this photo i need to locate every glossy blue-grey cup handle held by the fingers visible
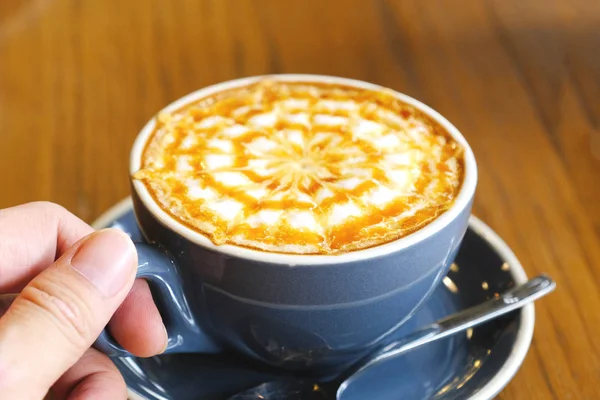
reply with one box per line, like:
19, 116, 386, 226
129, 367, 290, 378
94, 243, 220, 357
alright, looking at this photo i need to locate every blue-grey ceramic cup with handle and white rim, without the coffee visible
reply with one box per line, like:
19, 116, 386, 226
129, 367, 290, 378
96, 75, 477, 371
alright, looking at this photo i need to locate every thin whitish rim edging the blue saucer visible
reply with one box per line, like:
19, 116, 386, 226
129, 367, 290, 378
91, 197, 535, 400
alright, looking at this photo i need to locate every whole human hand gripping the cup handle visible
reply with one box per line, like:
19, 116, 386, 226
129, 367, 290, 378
0, 202, 167, 400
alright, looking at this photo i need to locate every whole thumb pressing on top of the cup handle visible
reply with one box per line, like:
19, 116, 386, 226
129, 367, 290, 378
0, 229, 137, 399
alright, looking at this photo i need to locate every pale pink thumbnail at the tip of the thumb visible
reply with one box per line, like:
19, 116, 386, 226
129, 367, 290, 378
71, 229, 136, 297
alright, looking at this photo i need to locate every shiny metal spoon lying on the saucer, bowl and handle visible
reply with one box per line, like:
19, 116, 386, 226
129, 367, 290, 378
228, 275, 556, 400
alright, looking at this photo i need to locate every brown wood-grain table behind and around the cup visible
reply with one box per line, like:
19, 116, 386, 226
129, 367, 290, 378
0, 0, 600, 400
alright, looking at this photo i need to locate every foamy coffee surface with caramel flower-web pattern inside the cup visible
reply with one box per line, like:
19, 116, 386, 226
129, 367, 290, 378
134, 80, 464, 254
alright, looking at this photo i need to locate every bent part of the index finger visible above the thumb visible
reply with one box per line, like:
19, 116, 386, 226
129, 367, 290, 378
0, 202, 94, 293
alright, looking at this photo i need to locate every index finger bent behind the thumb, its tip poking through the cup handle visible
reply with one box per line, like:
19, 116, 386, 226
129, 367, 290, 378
0, 202, 167, 357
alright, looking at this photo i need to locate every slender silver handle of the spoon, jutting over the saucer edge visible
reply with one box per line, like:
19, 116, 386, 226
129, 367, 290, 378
352, 275, 556, 373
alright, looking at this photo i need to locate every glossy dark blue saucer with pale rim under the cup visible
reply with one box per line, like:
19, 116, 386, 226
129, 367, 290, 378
94, 199, 534, 400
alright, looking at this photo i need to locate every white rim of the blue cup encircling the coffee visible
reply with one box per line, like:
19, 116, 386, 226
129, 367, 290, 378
129, 74, 477, 266
